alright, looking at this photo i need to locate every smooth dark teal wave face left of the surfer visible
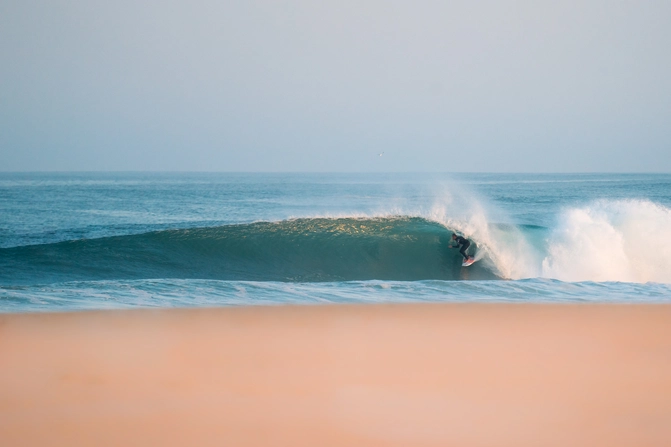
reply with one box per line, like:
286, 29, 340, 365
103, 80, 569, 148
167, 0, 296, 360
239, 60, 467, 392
0, 217, 498, 285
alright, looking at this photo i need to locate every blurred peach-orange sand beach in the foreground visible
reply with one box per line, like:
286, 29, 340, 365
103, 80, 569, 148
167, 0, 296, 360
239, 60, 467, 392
0, 304, 671, 447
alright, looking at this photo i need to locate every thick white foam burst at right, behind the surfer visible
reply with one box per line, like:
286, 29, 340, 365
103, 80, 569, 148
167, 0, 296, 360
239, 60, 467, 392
542, 200, 671, 283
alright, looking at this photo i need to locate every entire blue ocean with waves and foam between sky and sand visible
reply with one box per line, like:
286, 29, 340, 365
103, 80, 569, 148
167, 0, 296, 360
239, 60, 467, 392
0, 173, 671, 312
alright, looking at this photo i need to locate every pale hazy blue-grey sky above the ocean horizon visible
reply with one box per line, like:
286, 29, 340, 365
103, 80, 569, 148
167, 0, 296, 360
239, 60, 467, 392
0, 0, 671, 172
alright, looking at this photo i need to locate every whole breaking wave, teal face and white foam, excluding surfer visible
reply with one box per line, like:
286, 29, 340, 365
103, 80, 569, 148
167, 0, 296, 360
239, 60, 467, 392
0, 200, 671, 285
